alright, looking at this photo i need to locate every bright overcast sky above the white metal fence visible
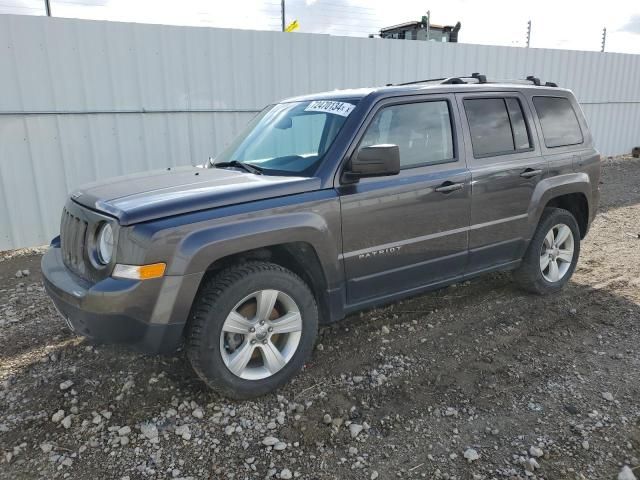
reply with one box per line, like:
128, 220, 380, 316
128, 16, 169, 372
0, 0, 640, 54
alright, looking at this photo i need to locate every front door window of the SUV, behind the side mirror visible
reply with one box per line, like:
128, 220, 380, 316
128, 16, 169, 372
360, 101, 454, 167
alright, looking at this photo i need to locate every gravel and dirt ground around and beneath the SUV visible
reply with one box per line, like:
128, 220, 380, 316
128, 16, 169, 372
0, 157, 640, 480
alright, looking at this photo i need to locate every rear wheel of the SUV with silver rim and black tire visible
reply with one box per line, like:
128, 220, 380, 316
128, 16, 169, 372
514, 208, 580, 295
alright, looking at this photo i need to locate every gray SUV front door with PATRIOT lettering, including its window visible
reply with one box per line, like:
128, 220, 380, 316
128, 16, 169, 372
338, 95, 471, 306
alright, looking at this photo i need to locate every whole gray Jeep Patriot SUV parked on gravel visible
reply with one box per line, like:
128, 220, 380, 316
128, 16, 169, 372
42, 74, 600, 398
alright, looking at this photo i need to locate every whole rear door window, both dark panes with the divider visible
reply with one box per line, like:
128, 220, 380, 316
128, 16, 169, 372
464, 98, 531, 157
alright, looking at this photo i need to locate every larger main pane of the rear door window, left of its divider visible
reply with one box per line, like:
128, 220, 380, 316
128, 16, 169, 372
464, 98, 514, 157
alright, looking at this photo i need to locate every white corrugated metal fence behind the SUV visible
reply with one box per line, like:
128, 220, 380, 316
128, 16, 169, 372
0, 15, 640, 250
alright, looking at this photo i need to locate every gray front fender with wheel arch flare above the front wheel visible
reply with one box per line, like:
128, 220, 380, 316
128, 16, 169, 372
159, 208, 345, 336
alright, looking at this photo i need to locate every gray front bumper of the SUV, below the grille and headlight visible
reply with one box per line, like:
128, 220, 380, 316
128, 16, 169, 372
42, 246, 201, 353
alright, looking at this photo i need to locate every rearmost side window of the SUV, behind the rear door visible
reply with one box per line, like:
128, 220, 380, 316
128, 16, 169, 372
533, 97, 583, 148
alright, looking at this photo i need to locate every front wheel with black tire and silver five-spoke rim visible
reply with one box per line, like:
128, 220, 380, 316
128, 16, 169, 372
186, 262, 318, 399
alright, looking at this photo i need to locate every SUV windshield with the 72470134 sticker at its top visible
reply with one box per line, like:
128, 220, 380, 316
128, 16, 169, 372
214, 100, 357, 175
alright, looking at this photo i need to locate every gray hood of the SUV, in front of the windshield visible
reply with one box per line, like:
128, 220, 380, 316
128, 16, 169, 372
71, 167, 320, 225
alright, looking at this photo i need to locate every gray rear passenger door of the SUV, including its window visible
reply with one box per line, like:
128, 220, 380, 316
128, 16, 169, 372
456, 91, 548, 273
